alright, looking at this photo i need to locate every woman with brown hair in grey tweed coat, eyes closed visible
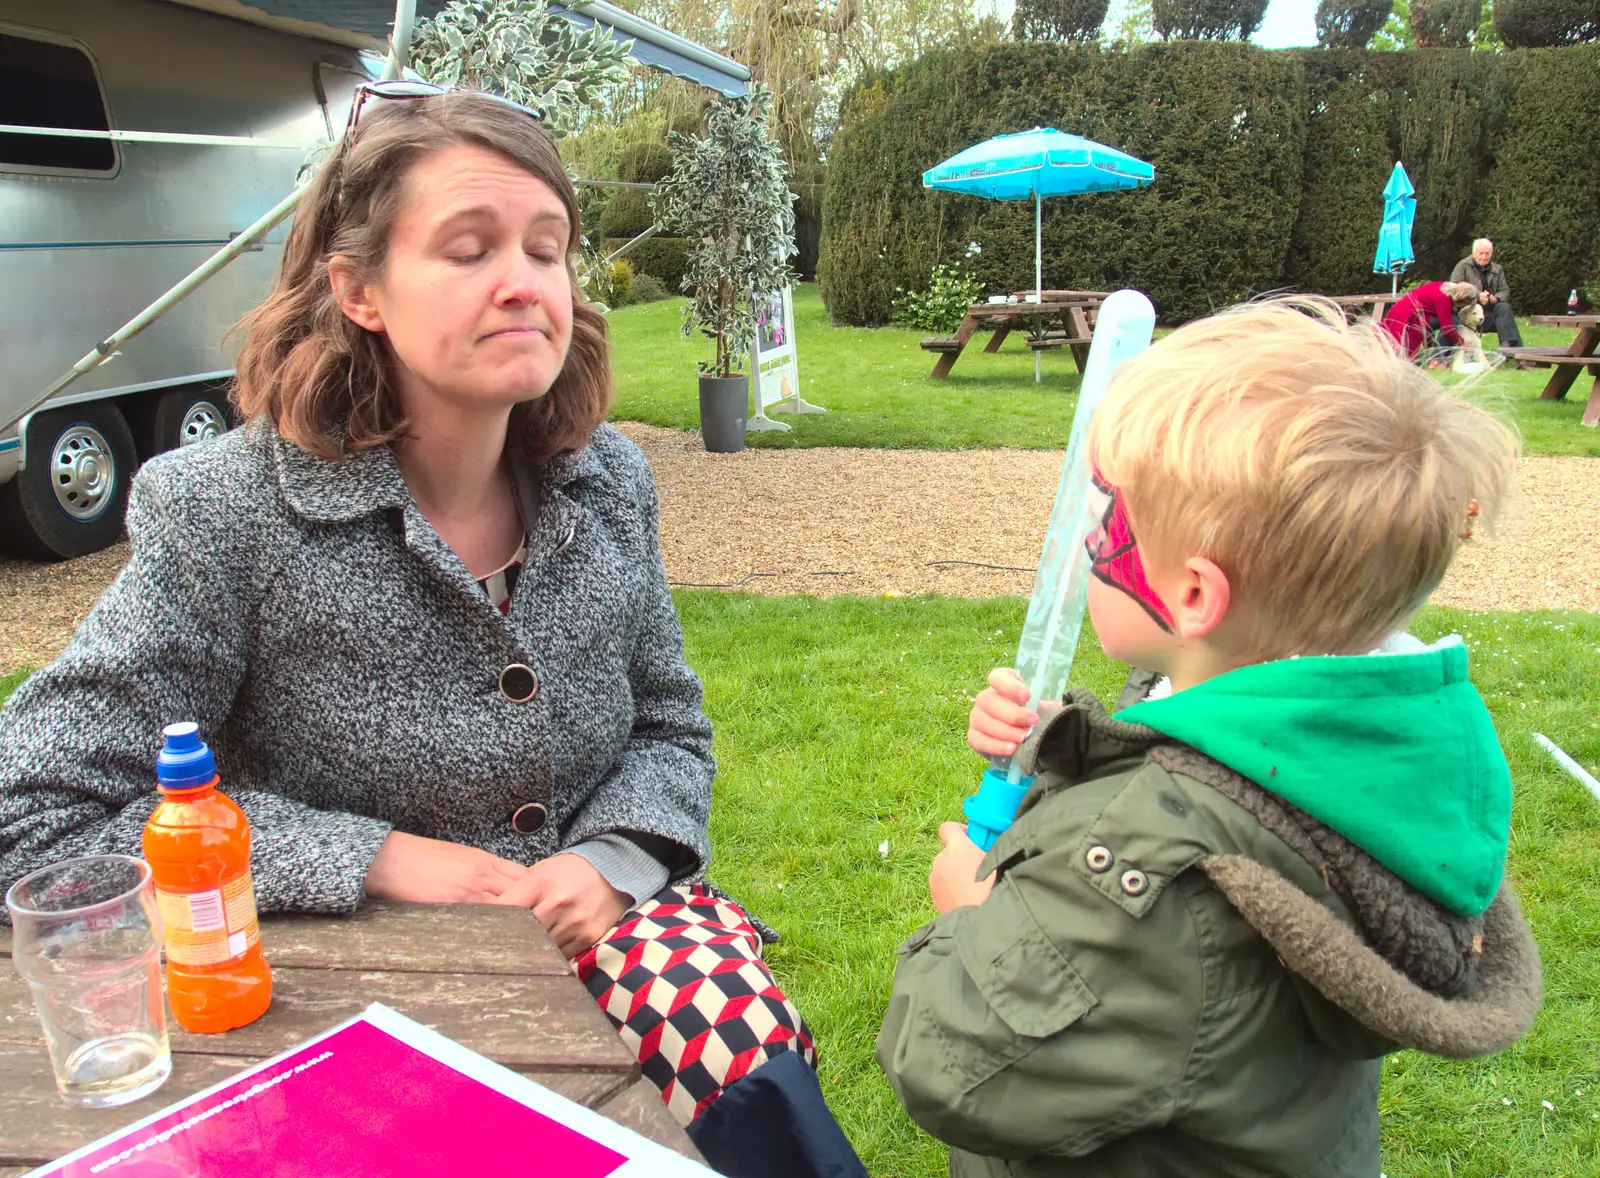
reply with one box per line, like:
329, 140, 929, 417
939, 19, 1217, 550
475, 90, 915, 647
0, 83, 864, 1175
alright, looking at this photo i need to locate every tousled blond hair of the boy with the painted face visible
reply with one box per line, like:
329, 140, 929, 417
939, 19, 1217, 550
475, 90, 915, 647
1090, 299, 1517, 661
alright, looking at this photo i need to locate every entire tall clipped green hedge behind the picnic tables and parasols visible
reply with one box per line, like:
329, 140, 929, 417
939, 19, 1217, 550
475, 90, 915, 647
818, 42, 1600, 325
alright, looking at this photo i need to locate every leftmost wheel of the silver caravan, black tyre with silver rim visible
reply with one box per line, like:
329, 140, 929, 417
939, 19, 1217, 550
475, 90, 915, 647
0, 402, 139, 560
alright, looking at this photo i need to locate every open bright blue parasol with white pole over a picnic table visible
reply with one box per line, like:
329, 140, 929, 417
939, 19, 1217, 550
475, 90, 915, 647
922, 126, 1155, 381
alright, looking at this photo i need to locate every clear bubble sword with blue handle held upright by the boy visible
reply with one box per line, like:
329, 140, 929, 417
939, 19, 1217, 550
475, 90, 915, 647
962, 290, 1155, 850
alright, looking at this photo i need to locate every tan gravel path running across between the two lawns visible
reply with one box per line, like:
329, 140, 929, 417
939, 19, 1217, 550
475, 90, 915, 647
0, 424, 1600, 674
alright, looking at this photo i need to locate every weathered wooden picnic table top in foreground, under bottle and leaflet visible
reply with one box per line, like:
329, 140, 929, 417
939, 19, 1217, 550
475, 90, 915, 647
0, 901, 701, 1178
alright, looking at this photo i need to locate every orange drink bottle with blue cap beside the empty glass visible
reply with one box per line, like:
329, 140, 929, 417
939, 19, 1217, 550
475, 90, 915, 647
144, 723, 272, 1034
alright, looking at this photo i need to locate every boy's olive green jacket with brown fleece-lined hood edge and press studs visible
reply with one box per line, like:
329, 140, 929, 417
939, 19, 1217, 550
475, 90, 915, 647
878, 675, 1539, 1178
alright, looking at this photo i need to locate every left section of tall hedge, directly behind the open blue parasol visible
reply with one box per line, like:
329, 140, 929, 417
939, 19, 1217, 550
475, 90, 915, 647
818, 42, 1306, 323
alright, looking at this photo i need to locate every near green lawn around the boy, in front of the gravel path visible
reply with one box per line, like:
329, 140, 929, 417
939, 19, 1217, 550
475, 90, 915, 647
0, 592, 1600, 1178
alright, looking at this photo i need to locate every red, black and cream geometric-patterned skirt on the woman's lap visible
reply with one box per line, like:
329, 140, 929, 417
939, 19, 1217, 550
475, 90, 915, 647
573, 884, 816, 1125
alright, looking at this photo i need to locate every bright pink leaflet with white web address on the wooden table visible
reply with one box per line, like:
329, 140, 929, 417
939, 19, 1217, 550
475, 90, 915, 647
56, 1023, 627, 1178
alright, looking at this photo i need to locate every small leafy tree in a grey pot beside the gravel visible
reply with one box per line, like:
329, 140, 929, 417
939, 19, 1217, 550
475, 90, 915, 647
650, 86, 795, 453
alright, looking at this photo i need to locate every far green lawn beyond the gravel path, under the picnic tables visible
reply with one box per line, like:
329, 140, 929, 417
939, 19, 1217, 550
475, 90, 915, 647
611, 283, 1600, 456
